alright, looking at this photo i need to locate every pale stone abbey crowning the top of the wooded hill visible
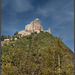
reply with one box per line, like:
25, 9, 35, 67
18, 18, 51, 37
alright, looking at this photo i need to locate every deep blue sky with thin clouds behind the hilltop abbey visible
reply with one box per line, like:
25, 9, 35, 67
1, 0, 74, 51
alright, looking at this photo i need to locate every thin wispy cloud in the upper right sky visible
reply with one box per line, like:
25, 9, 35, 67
37, 0, 74, 21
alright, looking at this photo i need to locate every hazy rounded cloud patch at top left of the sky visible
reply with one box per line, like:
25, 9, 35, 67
11, 0, 33, 12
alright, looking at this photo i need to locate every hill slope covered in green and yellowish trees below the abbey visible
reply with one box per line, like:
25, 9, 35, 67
1, 32, 74, 75
